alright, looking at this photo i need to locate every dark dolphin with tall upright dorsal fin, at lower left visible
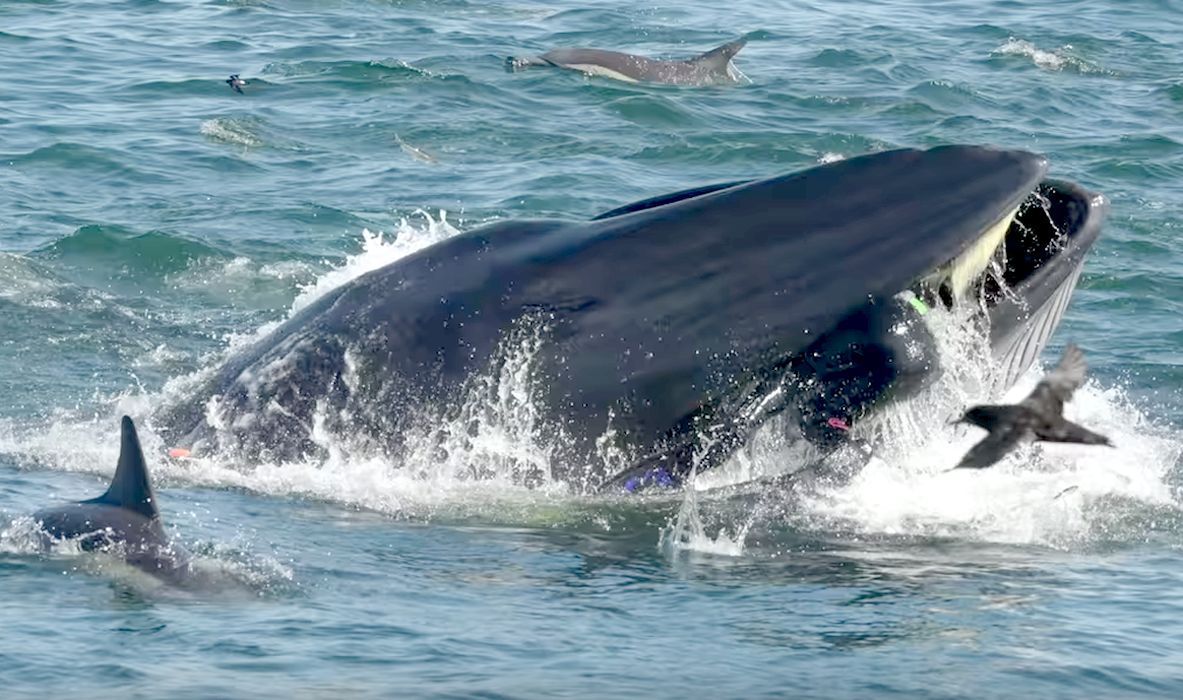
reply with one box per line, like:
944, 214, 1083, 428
33, 416, 189, 582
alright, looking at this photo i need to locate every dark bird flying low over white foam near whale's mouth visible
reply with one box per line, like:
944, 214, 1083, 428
953, 344, 1113, 469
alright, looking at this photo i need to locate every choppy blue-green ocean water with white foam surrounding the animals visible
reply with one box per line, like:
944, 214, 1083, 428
0, 0, 1183, 698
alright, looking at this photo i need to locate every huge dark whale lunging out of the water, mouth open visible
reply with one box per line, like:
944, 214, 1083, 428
153, 145, 1108, 493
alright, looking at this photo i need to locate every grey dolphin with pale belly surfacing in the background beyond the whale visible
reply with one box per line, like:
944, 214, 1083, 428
505, 39, 748, 85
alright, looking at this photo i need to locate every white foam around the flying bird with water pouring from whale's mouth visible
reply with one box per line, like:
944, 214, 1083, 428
803, 297, 1183, 546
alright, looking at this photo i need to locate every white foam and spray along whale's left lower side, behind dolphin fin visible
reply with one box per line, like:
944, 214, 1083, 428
0, 286, 570, 524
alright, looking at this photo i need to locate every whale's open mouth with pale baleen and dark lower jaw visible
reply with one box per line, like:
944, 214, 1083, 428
776, 180, 1107, 475
